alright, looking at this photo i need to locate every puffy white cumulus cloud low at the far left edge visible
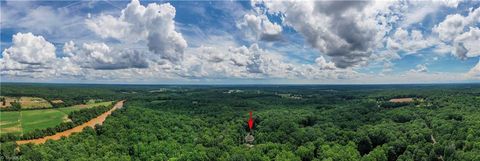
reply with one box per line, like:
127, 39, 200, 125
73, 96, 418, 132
0, 33, 84, 79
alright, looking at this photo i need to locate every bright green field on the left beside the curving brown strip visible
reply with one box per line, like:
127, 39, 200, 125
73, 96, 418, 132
0, 101, 112, 134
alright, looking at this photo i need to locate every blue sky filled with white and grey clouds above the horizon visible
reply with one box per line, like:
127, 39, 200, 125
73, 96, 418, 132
0, 0, 480, 84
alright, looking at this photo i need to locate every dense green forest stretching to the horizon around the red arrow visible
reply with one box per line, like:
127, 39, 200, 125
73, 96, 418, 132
0, 83, 480, 161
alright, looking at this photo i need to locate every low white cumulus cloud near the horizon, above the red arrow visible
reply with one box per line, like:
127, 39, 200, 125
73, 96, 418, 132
178, 44, 286, 78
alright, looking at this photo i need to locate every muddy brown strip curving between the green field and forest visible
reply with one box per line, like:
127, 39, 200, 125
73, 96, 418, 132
17, 101, 124, 145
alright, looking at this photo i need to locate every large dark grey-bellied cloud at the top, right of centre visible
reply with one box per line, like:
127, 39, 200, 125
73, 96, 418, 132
256, 1, 384, 68
